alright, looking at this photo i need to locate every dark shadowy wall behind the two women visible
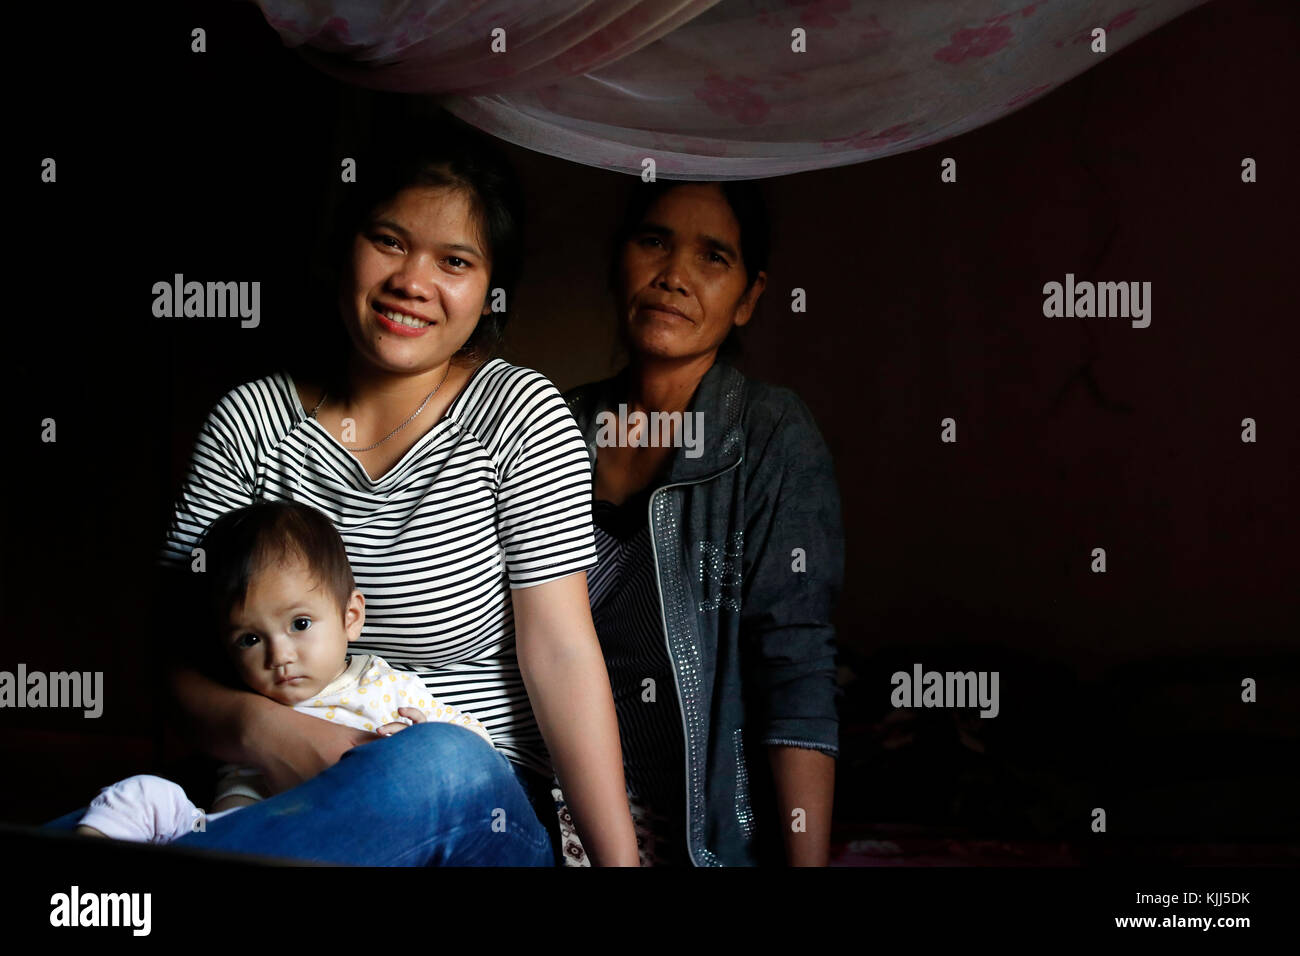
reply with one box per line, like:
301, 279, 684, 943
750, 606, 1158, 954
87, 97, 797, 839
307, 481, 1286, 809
0, 0, 1300, 832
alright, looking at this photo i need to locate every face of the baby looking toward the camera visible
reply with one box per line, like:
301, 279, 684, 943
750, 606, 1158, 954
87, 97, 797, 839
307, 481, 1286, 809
224, 559, 363, 705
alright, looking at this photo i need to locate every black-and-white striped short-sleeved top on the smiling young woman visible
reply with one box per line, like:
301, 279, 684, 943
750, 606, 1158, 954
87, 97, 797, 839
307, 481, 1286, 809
160, 359, 595, 775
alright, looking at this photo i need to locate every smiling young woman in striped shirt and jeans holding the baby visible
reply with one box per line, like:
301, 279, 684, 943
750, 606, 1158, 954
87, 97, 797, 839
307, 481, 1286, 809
153, 130, 637, 865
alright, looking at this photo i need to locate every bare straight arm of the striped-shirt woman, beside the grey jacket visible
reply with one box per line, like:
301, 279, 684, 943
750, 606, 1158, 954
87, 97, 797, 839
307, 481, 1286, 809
511, 572, 638, 866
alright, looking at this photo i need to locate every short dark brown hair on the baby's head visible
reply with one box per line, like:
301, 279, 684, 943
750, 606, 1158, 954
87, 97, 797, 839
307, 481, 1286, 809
199, 501, 356, 642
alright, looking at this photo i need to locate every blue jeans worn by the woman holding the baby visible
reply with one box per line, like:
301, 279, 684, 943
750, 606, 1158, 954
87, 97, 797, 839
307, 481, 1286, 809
46, 723, 555, 866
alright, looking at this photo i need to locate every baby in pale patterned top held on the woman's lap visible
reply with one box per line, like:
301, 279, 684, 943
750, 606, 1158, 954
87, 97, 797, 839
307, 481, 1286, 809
77, 502, 493, 843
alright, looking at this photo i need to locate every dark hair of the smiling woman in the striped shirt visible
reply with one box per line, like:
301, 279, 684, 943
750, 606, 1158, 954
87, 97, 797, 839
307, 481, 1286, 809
299, 116, 524, 390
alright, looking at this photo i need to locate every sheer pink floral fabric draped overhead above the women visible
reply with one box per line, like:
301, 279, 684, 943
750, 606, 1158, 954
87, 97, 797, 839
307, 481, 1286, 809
257, 0, 1205, 179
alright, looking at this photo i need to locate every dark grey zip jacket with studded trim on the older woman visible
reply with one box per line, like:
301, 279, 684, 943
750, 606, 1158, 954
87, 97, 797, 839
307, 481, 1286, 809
566, 363, 844, 866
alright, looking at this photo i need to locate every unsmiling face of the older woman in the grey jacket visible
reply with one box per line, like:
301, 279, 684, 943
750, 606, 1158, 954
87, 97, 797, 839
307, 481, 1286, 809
616, 183, 767, 359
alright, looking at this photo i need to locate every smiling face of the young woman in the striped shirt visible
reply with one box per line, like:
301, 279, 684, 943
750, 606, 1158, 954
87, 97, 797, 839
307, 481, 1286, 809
339, 186, 491, 372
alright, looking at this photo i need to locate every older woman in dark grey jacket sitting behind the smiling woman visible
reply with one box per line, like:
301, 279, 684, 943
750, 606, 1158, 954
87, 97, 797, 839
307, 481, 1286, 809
566, 183, 844, 866
